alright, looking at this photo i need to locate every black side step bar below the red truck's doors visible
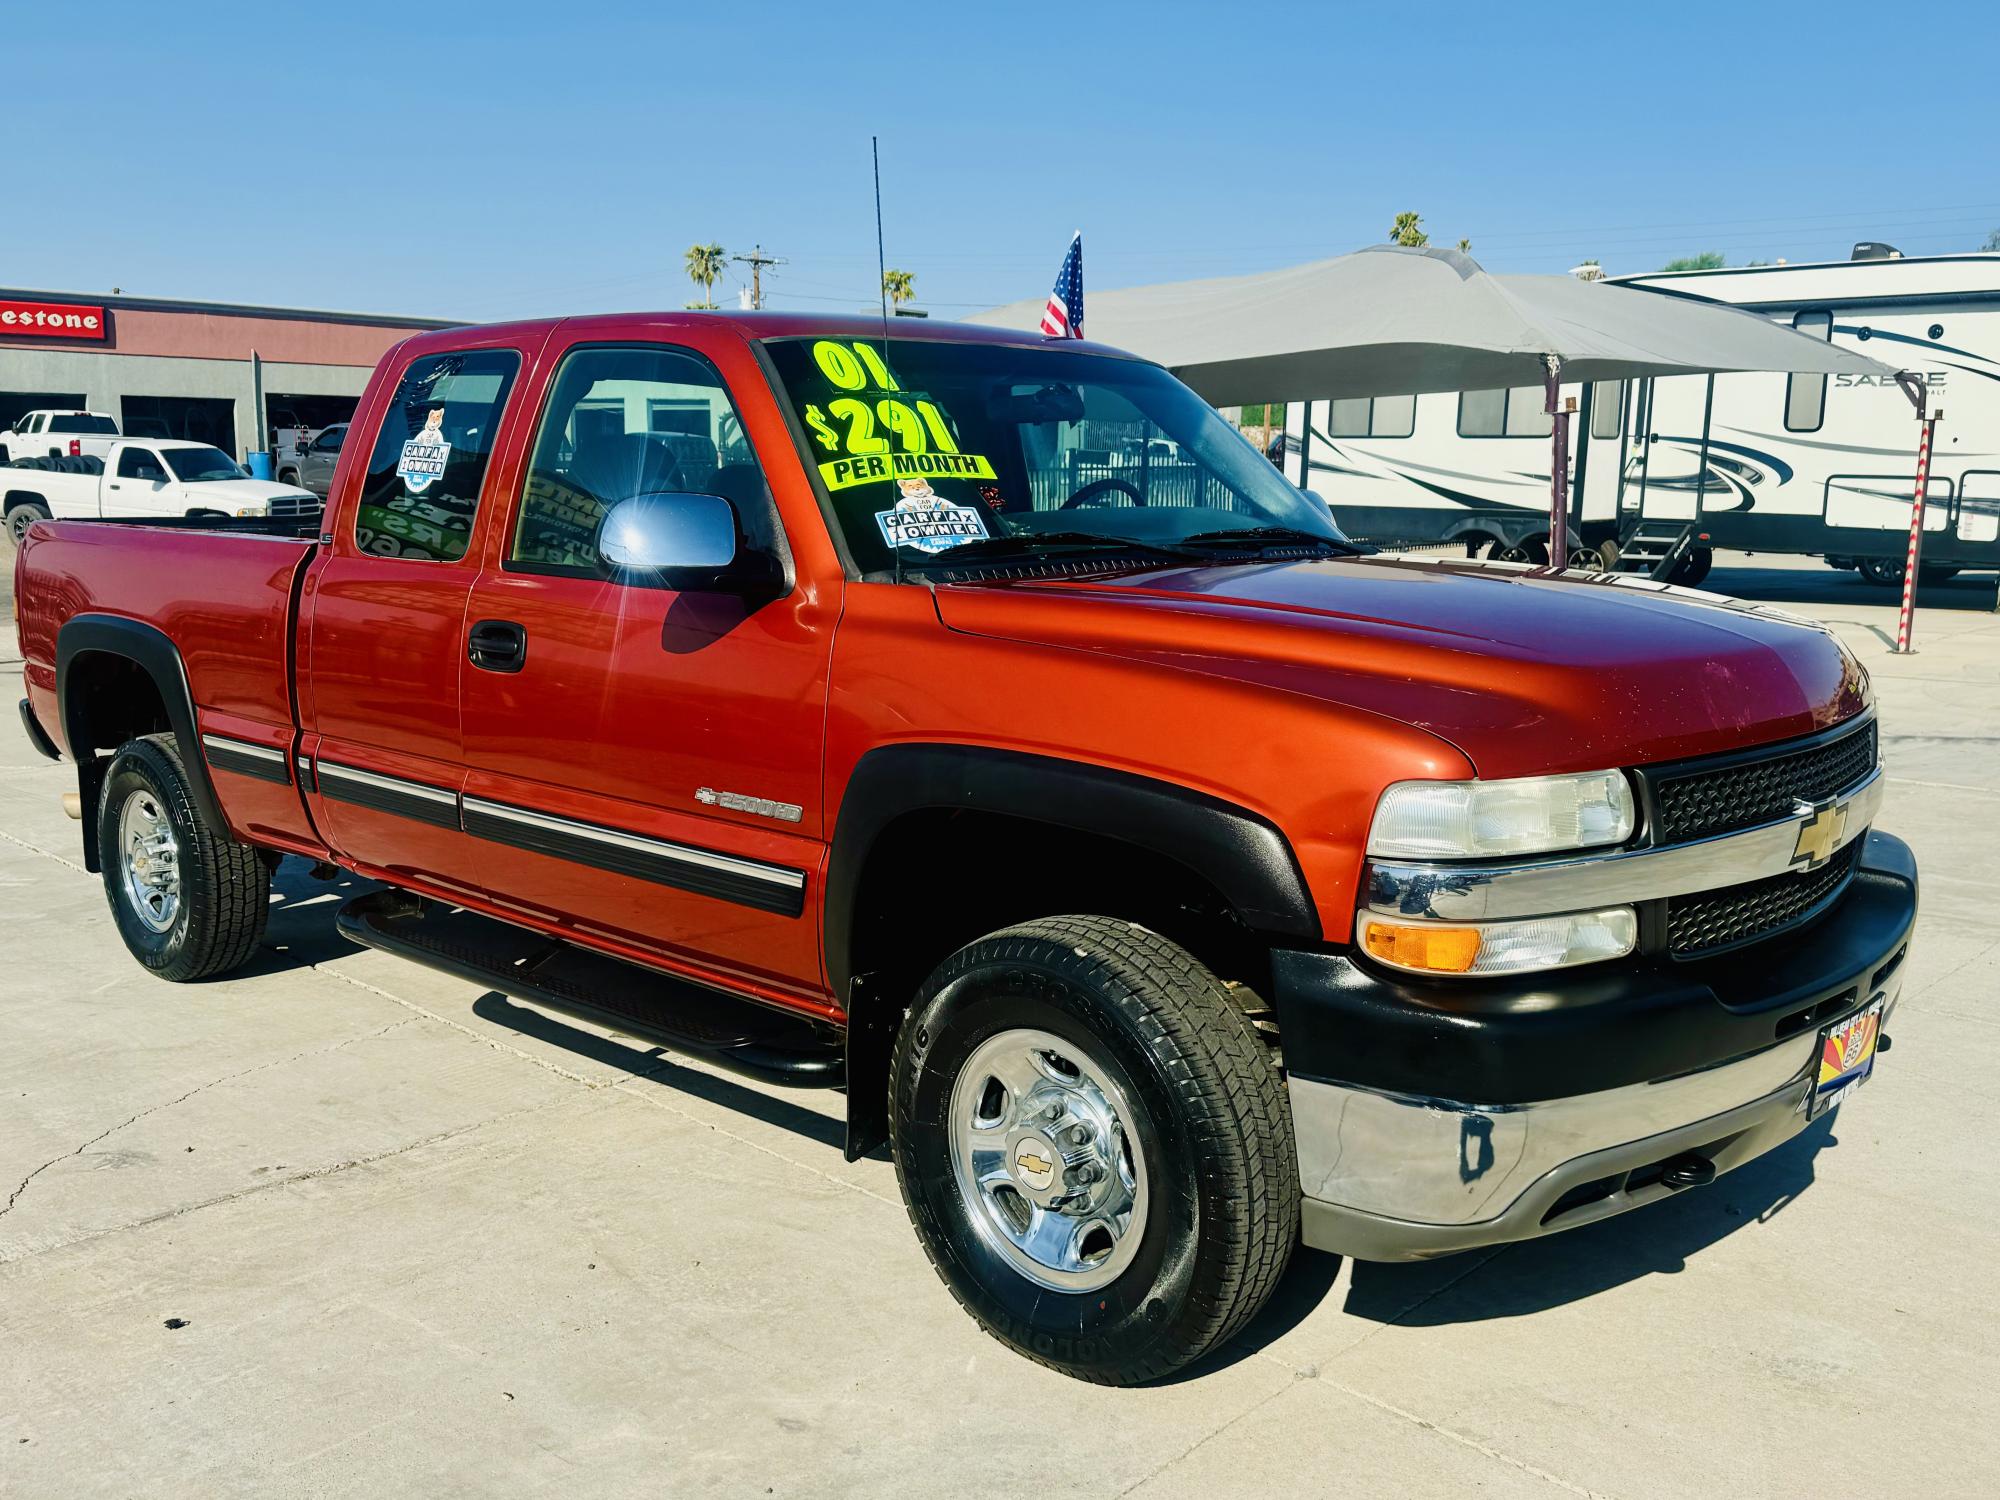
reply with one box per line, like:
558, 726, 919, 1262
338, 890, 846, 1088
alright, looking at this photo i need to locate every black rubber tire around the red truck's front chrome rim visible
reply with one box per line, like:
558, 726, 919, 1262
890, 916, 1298, 1386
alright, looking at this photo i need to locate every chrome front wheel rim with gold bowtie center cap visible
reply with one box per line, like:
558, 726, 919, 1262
950, 1030, 1146, 1292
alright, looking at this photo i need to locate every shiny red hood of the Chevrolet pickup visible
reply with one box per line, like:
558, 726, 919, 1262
936, 558, 1868, 778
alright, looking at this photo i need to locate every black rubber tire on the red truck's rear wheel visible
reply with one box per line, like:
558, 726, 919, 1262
98, 734, 270, 984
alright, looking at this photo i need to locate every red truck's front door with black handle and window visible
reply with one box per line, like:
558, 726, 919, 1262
462, 340, 838, 1002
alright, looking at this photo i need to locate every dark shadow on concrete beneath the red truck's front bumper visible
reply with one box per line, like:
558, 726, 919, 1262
1346, 1110, 1840, 1328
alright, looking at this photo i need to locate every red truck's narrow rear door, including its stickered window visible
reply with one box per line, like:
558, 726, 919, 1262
300, 336, 538, 894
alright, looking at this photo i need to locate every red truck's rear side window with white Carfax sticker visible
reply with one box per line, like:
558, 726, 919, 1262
354, 348, 520, 562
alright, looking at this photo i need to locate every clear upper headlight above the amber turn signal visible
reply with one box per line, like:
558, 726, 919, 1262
1368, 770, 1632, 860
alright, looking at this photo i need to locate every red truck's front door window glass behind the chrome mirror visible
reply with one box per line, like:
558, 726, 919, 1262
508, 344, 776, 576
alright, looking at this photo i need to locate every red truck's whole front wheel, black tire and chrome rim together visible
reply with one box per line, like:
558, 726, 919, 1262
890, 916, 1298, 1386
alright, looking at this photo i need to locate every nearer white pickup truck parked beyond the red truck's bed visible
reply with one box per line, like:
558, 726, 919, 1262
0, 438, 322, 546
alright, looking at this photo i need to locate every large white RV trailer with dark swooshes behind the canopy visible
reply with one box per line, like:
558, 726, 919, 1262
1282, 244, 2000, 582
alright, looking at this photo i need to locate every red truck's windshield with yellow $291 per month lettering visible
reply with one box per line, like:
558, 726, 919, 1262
766, 338, 1354, 574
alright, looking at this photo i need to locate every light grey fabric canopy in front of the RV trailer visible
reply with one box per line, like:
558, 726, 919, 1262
972, 244, 1918, 558
